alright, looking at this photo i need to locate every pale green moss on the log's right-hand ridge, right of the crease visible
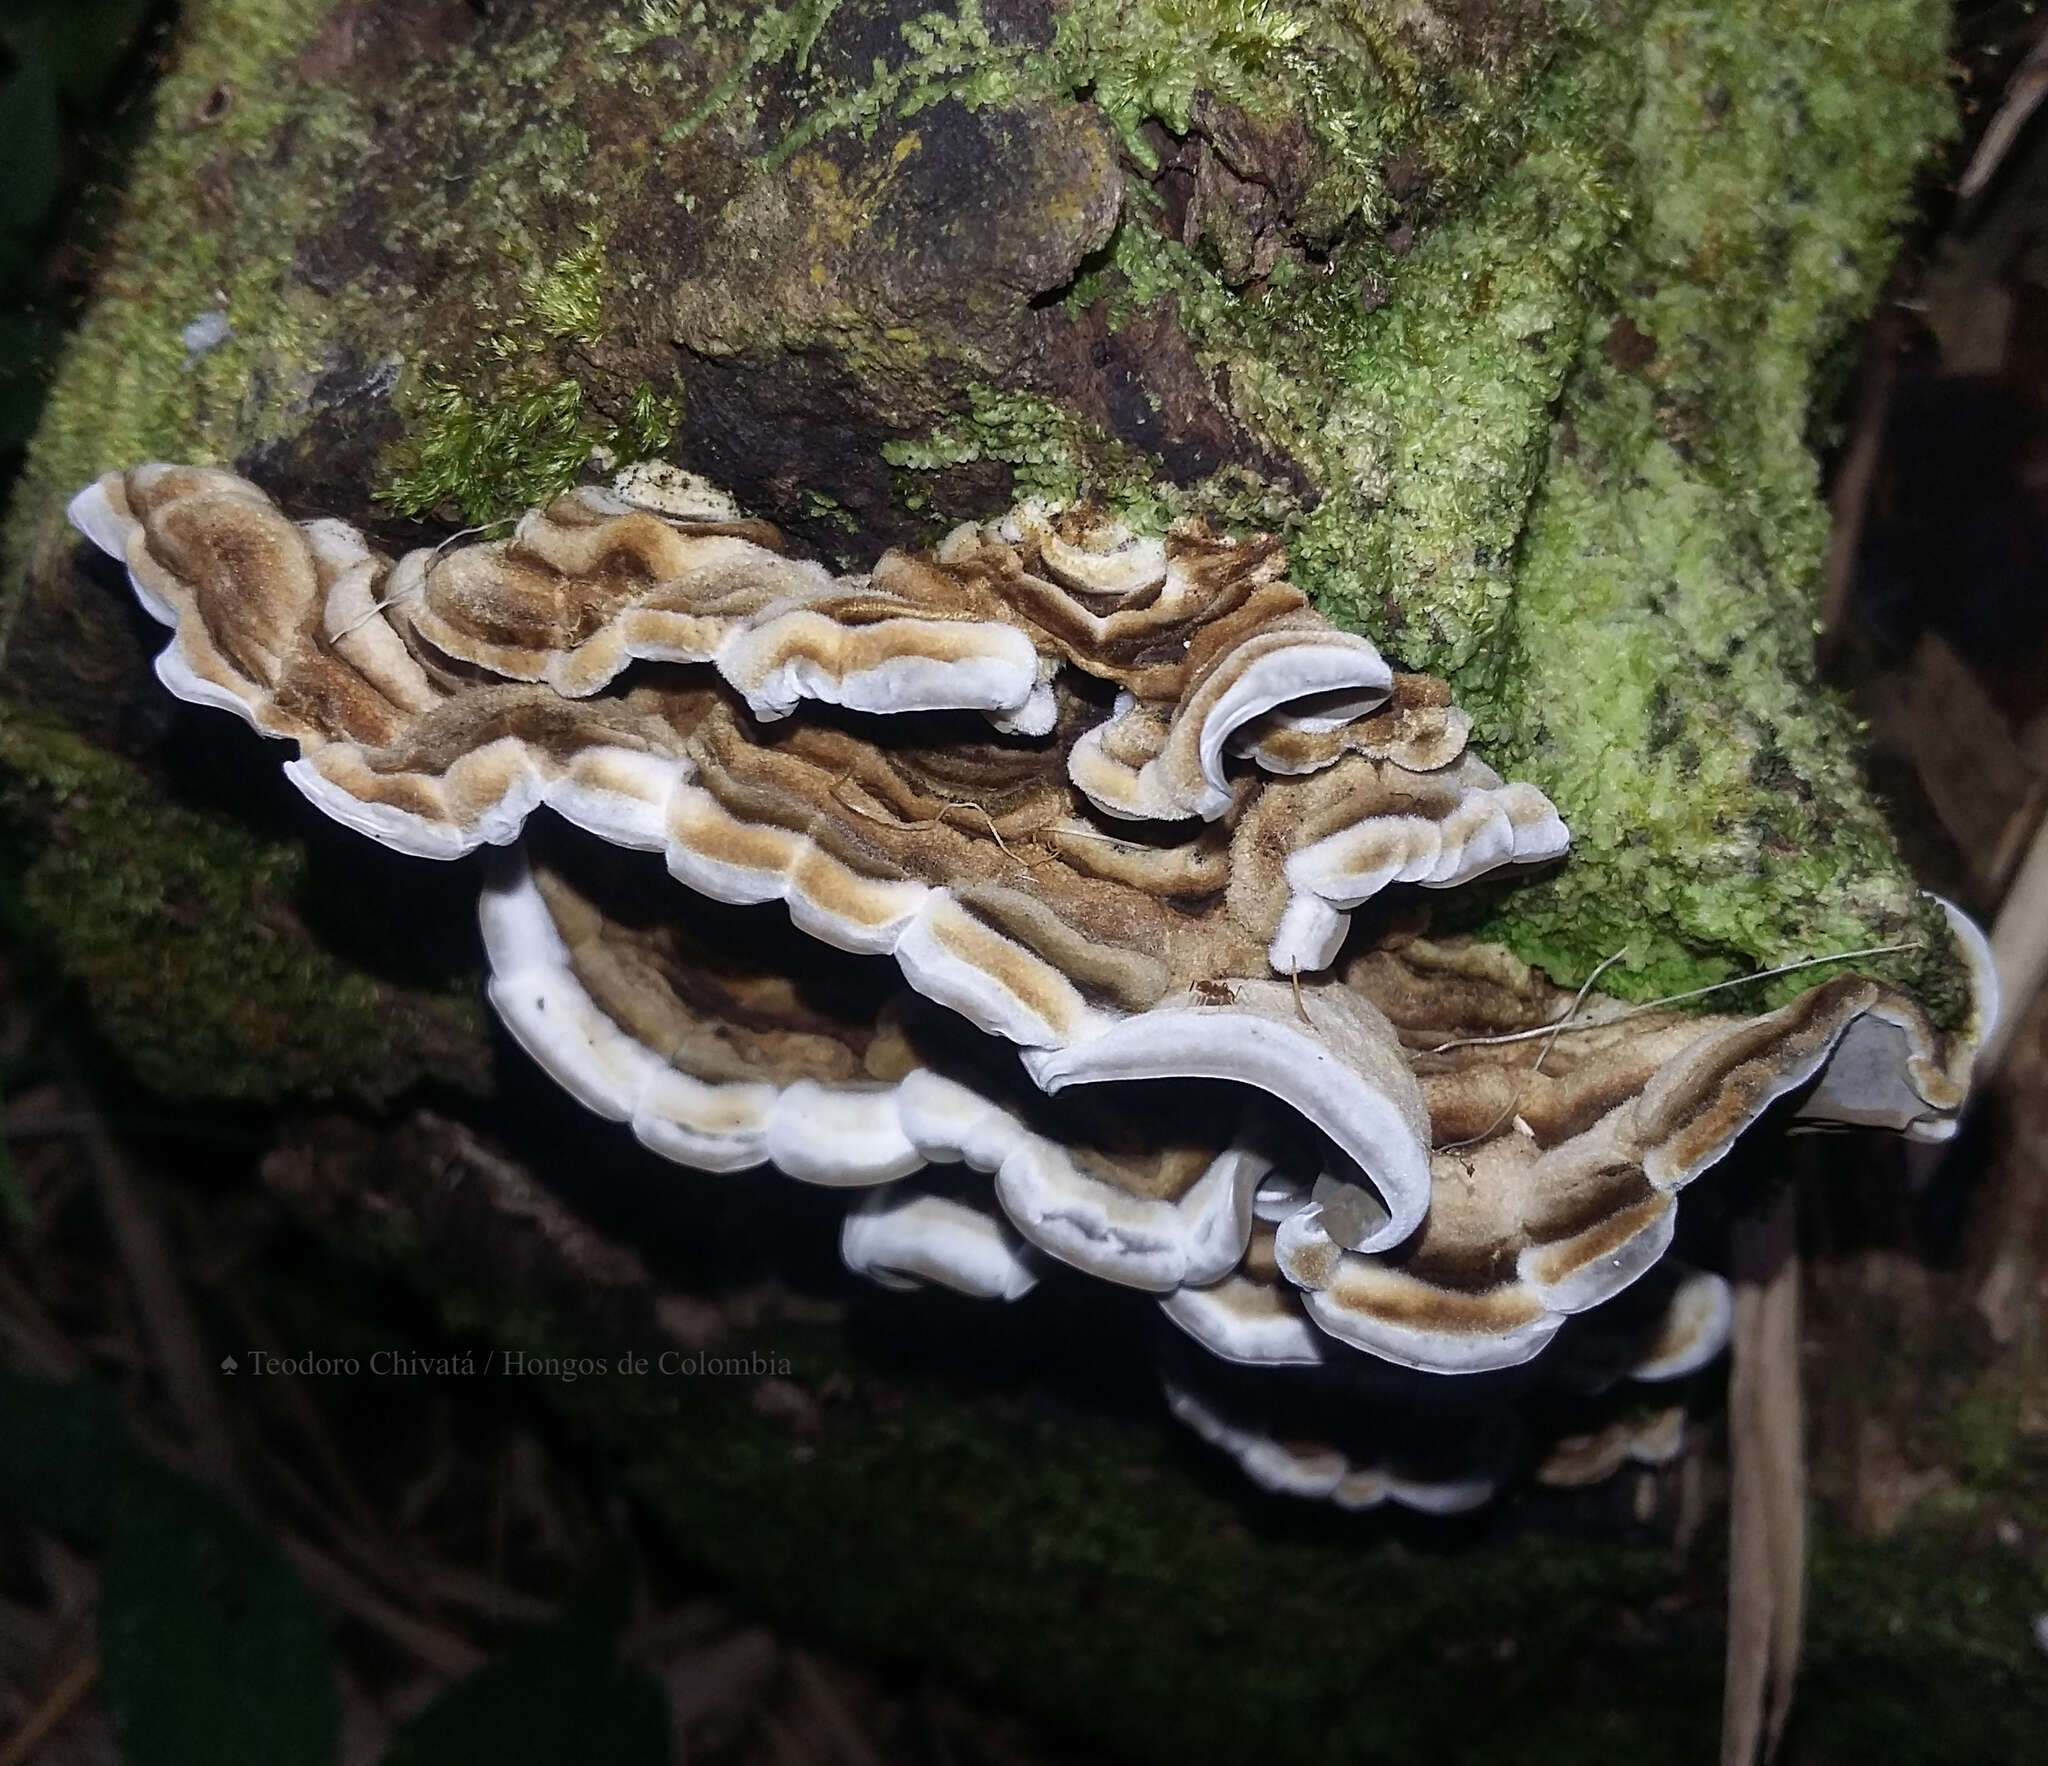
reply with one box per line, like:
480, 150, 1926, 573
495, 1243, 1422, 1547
1458, 0, 1956, 1006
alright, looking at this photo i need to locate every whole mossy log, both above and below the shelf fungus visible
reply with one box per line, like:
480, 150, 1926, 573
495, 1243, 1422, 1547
0, 0, 2025, 1760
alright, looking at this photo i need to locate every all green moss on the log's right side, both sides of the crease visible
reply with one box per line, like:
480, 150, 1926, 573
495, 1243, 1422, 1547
860, 0, 1962, 1018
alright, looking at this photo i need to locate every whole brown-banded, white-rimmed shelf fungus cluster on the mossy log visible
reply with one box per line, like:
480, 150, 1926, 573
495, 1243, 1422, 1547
72, 465, 1991, 1510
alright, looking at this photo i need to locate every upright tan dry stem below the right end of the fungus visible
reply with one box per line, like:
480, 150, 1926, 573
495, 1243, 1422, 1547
1720, 1184, 1806, 1766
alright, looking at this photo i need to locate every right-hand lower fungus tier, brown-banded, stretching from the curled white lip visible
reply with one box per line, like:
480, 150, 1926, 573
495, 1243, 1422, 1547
1236, 934, 1995, 1371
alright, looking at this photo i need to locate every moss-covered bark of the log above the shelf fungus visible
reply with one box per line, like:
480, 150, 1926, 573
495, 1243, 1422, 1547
0, 0, 1950, 1090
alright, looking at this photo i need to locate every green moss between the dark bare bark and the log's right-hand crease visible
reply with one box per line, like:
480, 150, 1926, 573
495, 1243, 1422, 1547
745, 0, 1638, 700
